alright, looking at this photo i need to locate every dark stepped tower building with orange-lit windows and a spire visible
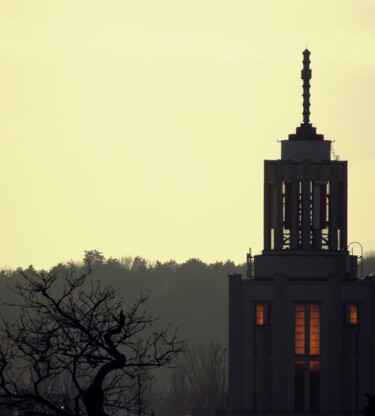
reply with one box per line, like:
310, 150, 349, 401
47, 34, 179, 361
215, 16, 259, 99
228, 50, 375, 416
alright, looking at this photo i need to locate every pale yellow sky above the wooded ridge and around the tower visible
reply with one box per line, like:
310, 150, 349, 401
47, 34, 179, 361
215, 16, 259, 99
0, 0, 375, 267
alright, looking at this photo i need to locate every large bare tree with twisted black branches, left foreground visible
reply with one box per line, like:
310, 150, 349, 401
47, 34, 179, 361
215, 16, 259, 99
0, 266, 184, 416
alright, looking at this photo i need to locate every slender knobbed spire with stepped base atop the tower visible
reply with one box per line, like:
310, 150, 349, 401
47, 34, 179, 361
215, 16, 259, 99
289, 49, 324, 141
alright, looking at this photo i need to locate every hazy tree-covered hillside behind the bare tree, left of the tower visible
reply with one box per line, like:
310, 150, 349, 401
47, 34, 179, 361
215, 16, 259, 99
0, 250, 245, 346
